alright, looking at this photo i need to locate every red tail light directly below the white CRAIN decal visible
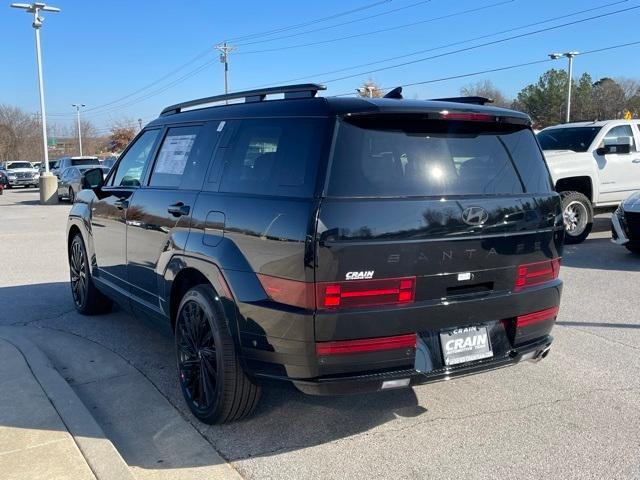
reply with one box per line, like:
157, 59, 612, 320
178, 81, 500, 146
316, 277, 416, 309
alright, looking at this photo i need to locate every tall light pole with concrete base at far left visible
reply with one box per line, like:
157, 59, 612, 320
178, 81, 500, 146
11, 3, 60, 204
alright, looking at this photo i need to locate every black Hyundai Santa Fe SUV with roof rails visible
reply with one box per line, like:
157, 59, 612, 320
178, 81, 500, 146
68, 84, 564, 423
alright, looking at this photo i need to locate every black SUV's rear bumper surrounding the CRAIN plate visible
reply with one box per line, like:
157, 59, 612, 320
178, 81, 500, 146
240, 280, 562, 395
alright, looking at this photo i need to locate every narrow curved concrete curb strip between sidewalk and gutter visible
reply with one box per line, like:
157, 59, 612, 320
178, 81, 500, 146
0, 327, 135, 480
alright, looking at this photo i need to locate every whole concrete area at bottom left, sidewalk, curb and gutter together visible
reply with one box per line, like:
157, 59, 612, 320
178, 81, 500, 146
0, 326, 241, 480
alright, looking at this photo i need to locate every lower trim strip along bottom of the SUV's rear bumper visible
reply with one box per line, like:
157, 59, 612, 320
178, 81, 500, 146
293, 335, 553, 395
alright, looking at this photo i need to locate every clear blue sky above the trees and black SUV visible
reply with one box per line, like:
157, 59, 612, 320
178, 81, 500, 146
0, 0, 640, 130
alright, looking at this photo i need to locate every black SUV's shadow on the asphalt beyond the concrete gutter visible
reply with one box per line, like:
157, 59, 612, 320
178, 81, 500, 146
0, 282, 427, 468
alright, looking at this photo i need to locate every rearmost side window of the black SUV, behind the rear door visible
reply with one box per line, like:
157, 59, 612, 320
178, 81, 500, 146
220, 118, 327, 197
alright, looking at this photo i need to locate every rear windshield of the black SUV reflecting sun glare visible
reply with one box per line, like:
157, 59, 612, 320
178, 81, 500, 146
328, 117, 551, 197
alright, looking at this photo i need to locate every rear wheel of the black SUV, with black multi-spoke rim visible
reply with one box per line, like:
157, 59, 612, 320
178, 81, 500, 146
175, 285, 260, 424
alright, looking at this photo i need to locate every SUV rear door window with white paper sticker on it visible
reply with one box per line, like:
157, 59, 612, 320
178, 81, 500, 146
149, 126, 201, 188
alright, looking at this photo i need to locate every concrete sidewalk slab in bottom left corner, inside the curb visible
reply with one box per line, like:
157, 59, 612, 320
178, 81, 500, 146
0, 339, 96, 480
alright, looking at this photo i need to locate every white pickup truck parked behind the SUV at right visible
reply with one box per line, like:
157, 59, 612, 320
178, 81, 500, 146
538, 120, 640, 243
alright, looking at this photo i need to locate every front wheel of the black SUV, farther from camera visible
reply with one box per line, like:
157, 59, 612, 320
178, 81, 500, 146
69, 233, 113, 315
